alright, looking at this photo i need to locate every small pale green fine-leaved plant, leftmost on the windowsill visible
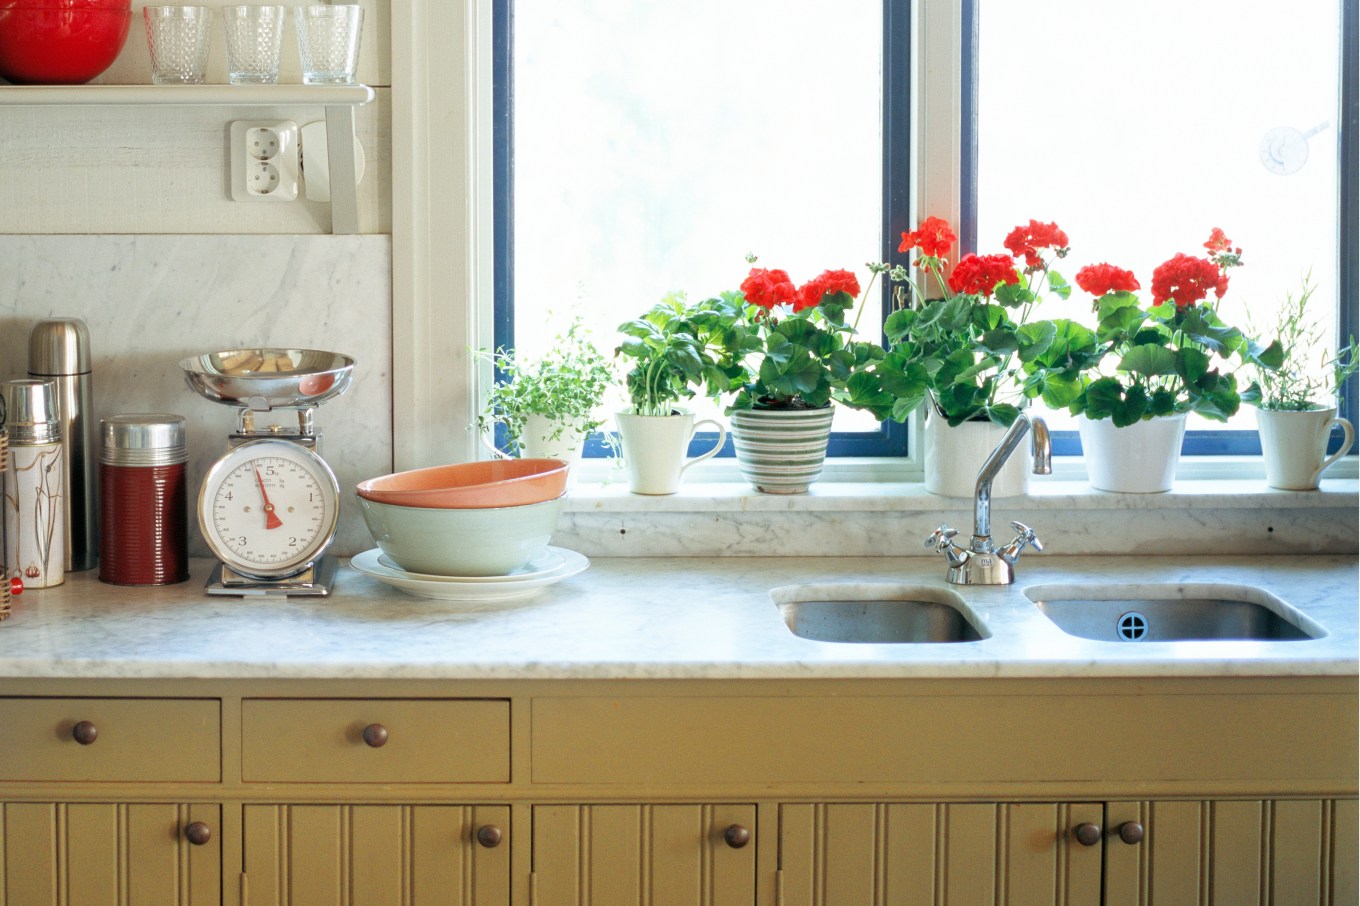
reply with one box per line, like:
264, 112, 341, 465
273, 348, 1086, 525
477, 316, 613, 453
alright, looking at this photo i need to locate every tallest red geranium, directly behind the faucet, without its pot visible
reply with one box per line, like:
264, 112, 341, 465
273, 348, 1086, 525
880, 216, 1072, 426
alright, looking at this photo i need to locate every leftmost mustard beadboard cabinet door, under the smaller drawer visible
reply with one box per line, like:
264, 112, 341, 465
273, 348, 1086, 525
0, 803, 222, 906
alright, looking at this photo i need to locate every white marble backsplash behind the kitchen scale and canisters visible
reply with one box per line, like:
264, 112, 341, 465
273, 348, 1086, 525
0, 235, 392, 555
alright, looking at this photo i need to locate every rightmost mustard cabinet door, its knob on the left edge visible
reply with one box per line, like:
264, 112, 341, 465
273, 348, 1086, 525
1106, 800, 1357, 906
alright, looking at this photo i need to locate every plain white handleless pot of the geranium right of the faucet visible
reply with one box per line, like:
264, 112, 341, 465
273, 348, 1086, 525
1077, 414, 1186, 494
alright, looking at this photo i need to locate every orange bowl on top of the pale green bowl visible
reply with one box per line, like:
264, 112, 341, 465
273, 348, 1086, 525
358, 460, 568, 510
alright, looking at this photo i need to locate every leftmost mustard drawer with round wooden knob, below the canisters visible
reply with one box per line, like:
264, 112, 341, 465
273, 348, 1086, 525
0, 698, 222, 782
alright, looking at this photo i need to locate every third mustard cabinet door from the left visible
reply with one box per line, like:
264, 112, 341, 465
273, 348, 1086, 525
533, 805, 756, 906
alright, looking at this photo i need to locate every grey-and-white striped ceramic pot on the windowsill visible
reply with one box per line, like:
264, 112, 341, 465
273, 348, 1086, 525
732, 405, 834, 494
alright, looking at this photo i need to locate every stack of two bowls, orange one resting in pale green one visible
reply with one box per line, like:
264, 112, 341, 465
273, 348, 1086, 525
358, 460, 568, 577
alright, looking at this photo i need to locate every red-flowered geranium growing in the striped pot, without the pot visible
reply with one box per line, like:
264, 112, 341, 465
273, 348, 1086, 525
696, 258, 891, 418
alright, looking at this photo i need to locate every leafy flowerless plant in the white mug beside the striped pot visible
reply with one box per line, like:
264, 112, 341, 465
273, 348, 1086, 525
615, 292, 729, 416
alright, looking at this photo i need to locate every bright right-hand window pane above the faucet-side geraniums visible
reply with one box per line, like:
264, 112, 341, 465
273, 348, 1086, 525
976, 0, 1340, 443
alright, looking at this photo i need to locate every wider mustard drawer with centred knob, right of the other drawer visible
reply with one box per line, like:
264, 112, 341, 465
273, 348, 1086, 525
241, 699, 510, 784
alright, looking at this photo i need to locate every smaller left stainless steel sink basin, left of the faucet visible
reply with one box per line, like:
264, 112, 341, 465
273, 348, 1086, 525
770, 584, 987, 643
